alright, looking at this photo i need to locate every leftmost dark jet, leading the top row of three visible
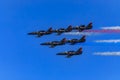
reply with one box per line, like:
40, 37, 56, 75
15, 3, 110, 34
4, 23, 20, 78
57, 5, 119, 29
28, 27, 53, 37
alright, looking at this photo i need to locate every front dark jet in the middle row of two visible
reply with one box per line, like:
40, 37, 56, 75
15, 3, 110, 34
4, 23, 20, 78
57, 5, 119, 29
41, 38, 66, 48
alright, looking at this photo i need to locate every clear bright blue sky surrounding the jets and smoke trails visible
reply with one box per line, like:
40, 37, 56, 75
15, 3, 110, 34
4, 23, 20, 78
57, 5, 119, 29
0, 0, 120, 80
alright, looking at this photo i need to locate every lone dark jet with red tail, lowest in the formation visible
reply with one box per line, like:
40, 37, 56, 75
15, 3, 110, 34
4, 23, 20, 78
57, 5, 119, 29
56, 48, 82, 58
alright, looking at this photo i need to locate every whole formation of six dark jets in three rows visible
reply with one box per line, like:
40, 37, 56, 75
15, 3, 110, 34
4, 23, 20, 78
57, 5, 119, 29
28, 22, 93, 58
